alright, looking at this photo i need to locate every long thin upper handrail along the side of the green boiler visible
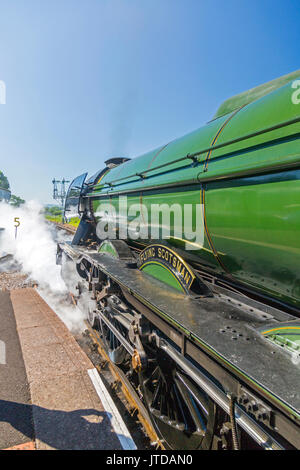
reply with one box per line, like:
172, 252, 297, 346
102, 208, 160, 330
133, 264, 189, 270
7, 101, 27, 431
104, 116, 300, 187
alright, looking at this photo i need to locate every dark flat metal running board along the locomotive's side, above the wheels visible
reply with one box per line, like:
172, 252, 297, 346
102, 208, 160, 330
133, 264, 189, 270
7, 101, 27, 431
58, 243, 300, 445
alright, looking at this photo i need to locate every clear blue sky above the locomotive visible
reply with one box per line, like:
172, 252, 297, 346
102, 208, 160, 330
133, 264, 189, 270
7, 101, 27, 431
0, 0, 300, 203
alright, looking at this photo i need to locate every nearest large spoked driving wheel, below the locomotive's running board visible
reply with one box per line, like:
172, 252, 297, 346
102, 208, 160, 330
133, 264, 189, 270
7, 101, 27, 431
139, 349, 216, 450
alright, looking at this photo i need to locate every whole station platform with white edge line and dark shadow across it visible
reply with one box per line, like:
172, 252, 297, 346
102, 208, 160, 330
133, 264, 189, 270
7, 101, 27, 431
0, 288, 136, 450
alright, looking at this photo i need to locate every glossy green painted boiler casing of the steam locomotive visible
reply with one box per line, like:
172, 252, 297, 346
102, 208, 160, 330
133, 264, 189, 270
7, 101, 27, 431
86, 72, 300, 308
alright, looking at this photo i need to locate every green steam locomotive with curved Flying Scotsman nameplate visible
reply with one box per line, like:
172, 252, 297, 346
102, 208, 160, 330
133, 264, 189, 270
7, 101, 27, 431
57, 70, 300, 449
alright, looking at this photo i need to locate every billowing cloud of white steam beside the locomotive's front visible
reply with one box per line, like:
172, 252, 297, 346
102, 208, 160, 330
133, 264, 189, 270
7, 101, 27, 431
0, 201, 84, 331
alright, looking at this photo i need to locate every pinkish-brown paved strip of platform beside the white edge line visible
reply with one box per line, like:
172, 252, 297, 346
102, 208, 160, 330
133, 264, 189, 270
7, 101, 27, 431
10, 288, 121, 450
